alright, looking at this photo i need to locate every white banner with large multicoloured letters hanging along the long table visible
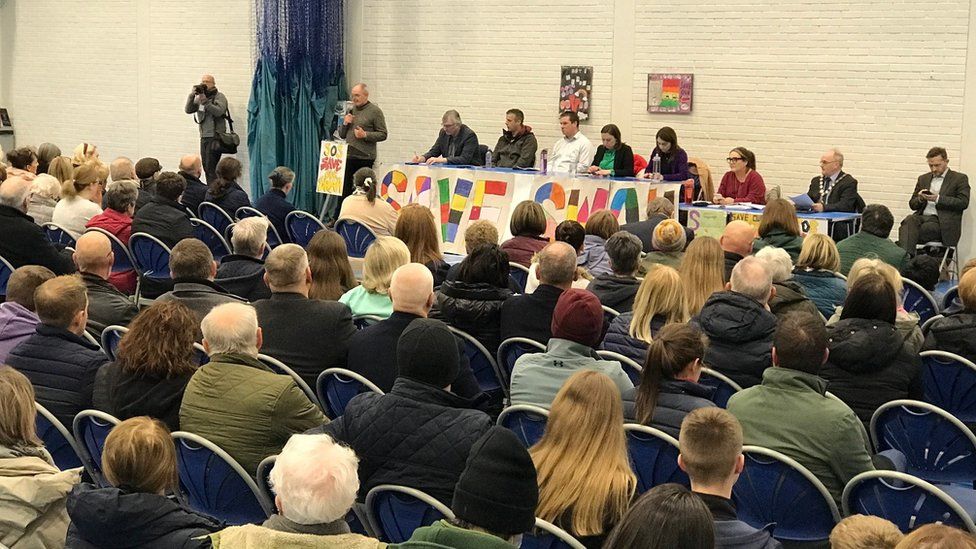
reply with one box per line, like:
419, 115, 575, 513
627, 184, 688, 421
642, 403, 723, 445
377, 164, 681, 254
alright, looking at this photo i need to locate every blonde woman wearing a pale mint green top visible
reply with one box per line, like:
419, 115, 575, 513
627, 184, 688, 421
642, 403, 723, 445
339, 236, 410, 318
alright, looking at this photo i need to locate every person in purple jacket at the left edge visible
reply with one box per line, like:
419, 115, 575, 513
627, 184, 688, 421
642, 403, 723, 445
0, 265, 54, 364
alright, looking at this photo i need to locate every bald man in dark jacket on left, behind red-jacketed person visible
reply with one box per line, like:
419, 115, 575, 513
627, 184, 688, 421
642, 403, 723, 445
74, 231, 139, 334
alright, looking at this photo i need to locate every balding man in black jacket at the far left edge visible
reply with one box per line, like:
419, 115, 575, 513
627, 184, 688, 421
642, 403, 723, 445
0, 176, 75, 274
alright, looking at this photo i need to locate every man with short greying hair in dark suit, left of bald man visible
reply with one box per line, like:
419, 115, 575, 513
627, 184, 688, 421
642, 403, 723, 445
254, 244, 356, 387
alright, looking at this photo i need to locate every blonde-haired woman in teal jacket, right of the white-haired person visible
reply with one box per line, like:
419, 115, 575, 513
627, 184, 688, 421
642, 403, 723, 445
793, 233, 847, 318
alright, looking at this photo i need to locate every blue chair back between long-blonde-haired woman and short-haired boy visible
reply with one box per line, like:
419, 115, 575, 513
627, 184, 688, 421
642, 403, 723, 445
624, 423, 691, 494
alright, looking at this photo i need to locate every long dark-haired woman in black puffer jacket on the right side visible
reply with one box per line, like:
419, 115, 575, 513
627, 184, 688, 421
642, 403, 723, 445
820, 273, 922, 425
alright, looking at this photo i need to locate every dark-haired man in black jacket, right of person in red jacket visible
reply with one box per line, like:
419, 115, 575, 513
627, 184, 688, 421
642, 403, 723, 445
132, 172, 194, 248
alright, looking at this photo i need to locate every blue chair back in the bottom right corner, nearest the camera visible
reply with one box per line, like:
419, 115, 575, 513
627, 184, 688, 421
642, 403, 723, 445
841, 471, 976, 533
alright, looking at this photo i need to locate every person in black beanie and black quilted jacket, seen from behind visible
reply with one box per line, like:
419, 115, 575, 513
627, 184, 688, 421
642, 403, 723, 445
315, 318, 491, 505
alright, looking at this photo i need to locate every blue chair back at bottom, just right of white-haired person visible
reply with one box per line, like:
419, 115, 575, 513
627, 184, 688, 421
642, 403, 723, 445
366, 484, 454, 543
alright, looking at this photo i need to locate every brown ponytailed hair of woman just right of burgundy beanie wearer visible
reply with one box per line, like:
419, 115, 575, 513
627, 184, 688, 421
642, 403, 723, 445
637, 324, 705, 425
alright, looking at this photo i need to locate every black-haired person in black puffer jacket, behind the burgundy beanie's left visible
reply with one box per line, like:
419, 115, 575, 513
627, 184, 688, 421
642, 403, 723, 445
430, 244, 513, 356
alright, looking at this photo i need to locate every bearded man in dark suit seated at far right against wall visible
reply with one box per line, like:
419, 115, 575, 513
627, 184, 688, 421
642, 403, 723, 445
898, 147, 969, 256
